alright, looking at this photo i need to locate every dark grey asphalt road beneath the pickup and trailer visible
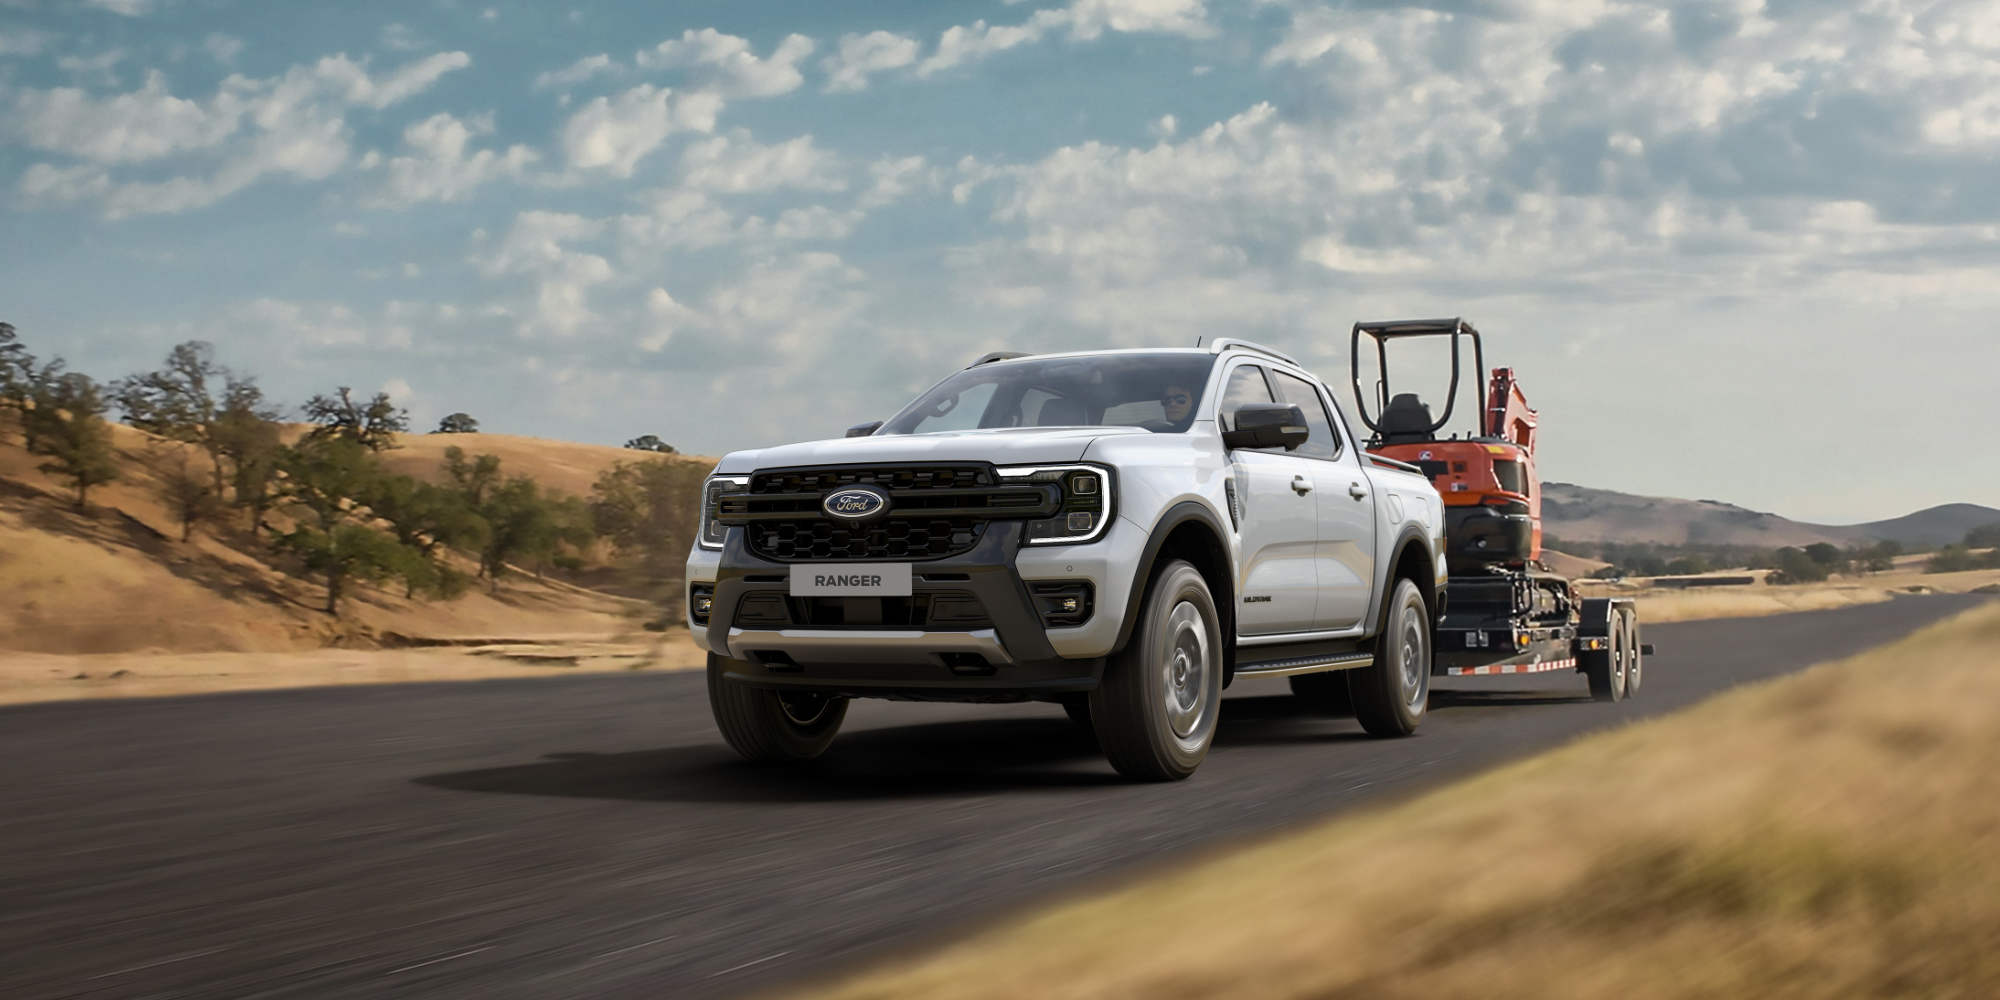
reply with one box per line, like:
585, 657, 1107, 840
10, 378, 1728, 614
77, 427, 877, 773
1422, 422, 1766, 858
0, 596, 1976, 998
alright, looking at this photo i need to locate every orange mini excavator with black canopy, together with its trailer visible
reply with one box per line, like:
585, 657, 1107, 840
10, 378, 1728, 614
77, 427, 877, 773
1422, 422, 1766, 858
1350, 318, 1652, 702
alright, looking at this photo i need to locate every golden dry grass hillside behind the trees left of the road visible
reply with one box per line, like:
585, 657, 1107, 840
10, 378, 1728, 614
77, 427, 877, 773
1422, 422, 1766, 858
0, 416, 712, 652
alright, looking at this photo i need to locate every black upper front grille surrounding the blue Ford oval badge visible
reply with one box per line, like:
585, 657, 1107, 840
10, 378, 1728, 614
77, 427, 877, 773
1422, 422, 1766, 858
716, 464, 1062, 562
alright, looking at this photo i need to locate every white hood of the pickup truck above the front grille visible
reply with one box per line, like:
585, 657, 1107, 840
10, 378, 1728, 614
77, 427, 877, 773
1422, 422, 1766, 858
716, 428, 1150, 474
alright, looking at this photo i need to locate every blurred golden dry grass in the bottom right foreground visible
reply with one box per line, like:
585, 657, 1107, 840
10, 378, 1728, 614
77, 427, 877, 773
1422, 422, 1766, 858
796, 604, 2000, 1000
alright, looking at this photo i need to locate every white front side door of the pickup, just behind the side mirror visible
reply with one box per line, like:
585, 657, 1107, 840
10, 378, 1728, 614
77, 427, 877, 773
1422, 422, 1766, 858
1216, 364, 1320, 636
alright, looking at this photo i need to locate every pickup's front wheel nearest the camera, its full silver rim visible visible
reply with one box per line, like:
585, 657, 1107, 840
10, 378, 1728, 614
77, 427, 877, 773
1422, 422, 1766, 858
1090, 560, 1222, 782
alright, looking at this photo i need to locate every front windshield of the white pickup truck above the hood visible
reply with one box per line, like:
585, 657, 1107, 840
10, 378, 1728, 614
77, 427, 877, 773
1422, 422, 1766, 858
882, 352, 1216, 434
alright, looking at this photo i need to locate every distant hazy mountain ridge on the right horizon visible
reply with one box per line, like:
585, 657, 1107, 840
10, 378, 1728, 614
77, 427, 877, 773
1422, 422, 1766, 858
1542, 482, 2000, 548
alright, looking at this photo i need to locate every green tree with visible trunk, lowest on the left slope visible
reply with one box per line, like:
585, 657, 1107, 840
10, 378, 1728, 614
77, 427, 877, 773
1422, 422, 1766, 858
278, 436, 412, 618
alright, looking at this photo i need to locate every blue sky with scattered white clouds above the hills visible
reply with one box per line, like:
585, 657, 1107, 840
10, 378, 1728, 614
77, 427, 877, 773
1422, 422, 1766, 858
0, 0, 2000, 522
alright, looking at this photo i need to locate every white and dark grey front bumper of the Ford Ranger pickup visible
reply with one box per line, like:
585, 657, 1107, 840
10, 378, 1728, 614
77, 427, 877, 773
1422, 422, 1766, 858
688, 518, 1144, 700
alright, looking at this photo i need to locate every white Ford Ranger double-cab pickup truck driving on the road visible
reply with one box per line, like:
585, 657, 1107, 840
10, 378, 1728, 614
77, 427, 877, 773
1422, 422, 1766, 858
686, 340, 1446, 780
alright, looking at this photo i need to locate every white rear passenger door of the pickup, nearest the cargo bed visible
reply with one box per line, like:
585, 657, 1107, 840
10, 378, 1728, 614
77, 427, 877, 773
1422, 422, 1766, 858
1270, 368, 1376, 628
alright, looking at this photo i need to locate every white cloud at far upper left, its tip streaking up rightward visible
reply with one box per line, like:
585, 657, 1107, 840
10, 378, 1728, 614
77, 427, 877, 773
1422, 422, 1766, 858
8, 52, 470, 218
